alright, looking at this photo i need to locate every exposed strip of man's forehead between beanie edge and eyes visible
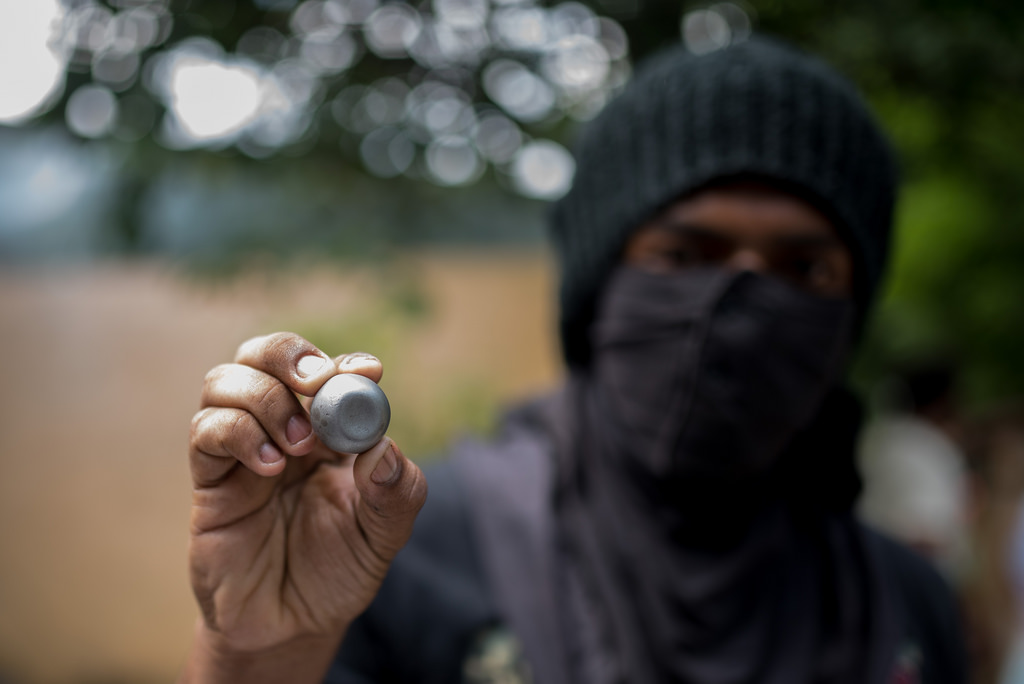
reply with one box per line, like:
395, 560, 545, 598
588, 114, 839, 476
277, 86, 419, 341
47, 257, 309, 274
641, 181, 840, 244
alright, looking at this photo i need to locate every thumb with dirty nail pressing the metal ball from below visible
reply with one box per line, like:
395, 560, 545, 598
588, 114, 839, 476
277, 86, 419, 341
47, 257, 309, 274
352, 437, 427, 560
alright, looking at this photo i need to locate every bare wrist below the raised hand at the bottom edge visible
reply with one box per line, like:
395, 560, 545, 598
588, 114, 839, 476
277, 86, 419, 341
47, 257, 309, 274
178, 617, 344, 684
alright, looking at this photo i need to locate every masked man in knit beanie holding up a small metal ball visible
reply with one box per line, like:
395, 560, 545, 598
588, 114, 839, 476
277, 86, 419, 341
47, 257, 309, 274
178, 39, 964, 684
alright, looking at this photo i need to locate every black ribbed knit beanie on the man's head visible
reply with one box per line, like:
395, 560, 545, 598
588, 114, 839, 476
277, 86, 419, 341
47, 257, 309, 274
551, 37, 896, 366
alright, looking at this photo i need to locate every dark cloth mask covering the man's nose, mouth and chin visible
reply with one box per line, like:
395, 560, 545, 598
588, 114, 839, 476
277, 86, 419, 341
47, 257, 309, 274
591, 266, 853, 478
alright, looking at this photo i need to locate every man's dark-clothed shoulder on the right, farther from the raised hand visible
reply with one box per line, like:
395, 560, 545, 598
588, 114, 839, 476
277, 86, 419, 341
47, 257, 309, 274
864, 526, 968, 684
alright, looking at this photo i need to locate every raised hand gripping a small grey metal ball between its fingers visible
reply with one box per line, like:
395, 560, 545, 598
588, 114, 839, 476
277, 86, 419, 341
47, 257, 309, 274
186, 333, 427, 681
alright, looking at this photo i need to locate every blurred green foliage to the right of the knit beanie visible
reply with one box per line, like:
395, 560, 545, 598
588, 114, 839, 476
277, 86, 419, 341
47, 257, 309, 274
757, 0, 1024, 409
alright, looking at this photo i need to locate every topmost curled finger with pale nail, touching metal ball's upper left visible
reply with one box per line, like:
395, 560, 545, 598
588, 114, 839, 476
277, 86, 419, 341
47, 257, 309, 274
234, 333, 337, 396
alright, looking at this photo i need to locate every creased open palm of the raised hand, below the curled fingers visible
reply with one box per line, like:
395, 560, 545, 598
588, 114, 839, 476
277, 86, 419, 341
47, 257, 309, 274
191, 447, 406, 650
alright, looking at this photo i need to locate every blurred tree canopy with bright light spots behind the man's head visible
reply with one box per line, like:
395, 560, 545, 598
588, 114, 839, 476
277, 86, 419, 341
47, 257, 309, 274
0, 0, 1024, 402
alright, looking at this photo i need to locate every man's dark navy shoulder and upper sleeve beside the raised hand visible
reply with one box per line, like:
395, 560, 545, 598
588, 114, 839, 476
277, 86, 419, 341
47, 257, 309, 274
327, 462, 498, 684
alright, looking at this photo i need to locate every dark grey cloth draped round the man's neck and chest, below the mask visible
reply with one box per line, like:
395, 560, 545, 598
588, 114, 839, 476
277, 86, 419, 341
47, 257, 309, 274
457, 382, 899, 684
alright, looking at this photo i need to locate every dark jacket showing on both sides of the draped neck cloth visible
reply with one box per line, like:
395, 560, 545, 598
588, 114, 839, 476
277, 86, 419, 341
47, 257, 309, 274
326, 411, 967, 684
